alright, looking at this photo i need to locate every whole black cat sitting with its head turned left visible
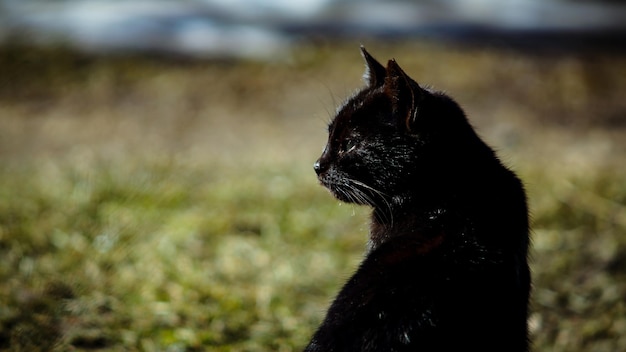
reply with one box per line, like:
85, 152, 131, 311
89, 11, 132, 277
306, 48, 530, 352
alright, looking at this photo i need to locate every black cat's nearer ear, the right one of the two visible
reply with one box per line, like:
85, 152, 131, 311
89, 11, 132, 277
385, 60, 424, 132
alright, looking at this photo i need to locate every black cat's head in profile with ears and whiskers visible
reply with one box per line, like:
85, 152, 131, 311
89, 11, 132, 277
314, 48, 471, 207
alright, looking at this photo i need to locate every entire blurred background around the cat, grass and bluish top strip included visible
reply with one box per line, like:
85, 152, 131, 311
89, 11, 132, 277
0, 0, 626, 351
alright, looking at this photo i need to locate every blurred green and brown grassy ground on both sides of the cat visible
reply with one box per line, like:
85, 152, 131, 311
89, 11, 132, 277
0, 44, 626, 351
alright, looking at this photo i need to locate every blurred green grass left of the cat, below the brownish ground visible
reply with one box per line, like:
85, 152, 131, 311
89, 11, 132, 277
0, 160, 366, 350
